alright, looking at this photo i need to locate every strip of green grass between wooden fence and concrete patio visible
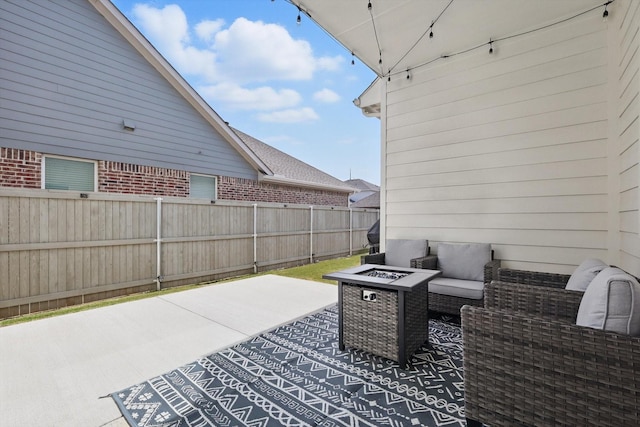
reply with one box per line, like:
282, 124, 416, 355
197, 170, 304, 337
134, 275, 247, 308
0, 255, 360, 327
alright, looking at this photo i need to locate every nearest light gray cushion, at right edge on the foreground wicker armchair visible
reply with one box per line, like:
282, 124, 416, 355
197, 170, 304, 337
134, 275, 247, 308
576, 267, 640, 336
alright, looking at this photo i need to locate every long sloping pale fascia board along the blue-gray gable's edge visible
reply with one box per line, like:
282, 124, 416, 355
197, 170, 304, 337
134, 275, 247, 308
88, 0, 273, 175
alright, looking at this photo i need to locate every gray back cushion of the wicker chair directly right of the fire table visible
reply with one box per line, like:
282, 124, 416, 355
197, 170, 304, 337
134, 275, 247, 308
438, 243, 491, 282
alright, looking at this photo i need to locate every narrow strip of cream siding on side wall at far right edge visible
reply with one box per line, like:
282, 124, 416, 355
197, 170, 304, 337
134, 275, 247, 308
615, 0, 640, 276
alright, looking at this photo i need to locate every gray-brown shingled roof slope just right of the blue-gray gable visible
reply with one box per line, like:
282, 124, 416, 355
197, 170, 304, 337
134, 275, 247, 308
232, 128, 355, 193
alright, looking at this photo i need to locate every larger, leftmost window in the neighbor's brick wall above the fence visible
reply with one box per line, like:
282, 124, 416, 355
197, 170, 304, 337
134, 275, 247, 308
42, 156, 96, 191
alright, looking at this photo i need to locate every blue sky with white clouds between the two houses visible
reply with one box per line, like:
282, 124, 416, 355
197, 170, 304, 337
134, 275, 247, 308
112, 0, 380, 185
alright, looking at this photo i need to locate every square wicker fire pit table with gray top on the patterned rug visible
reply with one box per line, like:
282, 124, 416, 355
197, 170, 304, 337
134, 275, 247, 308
322, 264, 441, 368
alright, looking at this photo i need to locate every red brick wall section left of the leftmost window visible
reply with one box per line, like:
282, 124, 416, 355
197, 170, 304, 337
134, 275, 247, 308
0, 148, 42, 188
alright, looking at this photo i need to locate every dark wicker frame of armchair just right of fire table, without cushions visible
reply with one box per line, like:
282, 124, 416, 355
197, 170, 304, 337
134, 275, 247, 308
411, 251, 500, 316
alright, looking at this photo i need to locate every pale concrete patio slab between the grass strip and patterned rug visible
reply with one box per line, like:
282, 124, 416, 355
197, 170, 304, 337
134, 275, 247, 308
0, 275, 338, 427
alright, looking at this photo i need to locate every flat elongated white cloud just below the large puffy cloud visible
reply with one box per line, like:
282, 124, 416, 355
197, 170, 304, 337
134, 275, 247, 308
198, 83, 302, 110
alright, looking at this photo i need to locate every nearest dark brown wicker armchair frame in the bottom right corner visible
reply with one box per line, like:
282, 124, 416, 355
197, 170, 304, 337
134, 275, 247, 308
462, 282, 640, 427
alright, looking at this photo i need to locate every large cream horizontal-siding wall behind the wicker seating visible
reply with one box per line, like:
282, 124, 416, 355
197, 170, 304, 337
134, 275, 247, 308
385, 10, 609, 272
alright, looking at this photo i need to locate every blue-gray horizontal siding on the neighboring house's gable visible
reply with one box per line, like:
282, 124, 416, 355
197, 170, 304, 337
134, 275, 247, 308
0, 0, 257, 179
